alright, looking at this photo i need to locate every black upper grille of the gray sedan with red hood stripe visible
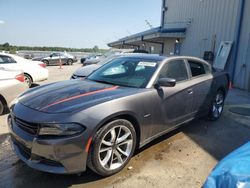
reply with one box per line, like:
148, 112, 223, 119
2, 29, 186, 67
12, 117, 39, 135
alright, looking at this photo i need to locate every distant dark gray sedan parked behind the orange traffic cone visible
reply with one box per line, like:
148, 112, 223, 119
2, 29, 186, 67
33, 52, 77, 66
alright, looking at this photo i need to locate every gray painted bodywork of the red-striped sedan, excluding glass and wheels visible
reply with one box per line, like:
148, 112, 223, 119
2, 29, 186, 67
8, 54, 228, 174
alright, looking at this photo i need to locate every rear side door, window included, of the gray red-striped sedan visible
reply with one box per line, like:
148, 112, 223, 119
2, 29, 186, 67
186, 59, 213, 116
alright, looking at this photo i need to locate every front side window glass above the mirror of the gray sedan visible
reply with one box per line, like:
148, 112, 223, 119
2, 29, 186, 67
159, 60, 188, 82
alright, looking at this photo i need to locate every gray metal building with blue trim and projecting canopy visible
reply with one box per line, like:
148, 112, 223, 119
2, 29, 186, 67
108, 0, 250, 91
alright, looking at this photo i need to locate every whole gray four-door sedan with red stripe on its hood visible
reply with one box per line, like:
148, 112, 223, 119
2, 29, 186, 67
8, 54, 229, 176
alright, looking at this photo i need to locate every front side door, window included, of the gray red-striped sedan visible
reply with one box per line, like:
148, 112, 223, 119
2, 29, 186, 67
150, 59, 194, 132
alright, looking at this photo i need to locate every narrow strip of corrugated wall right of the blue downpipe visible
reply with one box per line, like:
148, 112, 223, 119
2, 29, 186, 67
234, 0, 250, 91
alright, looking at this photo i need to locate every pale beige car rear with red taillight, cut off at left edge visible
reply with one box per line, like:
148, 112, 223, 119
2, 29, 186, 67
0, 67, 28, 115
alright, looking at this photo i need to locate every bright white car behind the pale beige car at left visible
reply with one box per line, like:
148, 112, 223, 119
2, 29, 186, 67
0, 53, 49, 87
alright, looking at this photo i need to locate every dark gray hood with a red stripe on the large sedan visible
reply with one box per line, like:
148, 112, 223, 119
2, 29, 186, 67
18, 80, 138, 113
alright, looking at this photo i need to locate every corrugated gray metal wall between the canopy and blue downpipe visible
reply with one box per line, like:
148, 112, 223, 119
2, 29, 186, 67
165, 0, 239, 57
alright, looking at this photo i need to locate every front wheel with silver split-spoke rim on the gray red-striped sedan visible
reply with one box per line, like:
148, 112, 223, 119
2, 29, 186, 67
88, 119, 136, 176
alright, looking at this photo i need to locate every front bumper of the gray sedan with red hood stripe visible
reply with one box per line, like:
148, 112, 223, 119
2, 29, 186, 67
9, 103, 88, 174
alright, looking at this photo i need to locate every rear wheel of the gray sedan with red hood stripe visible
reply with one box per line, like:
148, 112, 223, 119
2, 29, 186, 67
208, 90, 225, 121
